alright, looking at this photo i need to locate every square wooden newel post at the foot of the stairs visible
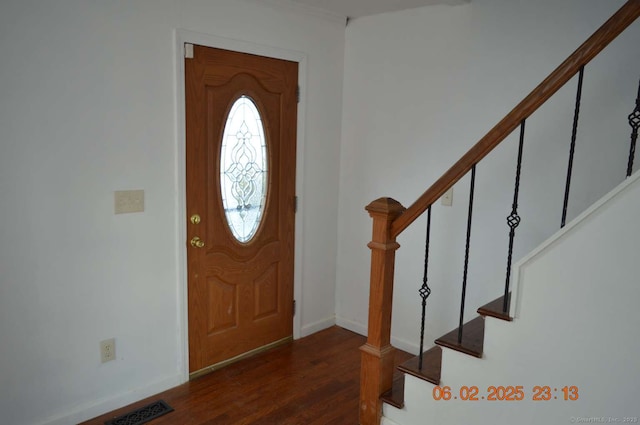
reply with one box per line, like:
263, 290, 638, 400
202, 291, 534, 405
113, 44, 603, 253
360, 198, 405, 425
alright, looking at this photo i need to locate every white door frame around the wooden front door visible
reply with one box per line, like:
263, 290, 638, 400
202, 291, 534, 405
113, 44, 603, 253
174, 29, 307, 382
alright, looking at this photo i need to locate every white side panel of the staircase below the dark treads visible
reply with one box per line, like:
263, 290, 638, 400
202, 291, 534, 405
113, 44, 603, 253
382, 173, 640, 425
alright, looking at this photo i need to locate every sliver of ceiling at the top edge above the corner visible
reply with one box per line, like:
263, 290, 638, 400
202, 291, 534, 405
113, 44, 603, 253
292, 0, 470, 18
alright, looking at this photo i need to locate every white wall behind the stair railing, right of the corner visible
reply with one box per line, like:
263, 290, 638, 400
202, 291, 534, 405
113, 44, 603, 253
336, 0, 640, 351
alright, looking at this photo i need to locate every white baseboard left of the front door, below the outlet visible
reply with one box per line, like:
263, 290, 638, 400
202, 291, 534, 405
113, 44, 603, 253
37, 373, 185, 425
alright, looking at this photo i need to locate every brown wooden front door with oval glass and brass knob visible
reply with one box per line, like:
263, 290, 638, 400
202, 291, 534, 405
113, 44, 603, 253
185, 46, 298, 373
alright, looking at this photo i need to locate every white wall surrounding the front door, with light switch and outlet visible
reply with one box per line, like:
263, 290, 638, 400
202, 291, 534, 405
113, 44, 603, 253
0, 0, 344, 424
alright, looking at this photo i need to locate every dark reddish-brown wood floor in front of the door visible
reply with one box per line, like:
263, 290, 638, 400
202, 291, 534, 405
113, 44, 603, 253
83, 326, 410, 425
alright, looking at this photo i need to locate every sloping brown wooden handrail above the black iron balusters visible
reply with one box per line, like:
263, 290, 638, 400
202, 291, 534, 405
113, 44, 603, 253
391, 0, 640, 237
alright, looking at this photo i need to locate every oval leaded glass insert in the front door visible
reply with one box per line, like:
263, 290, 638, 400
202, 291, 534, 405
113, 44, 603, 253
220, 96, 268, 243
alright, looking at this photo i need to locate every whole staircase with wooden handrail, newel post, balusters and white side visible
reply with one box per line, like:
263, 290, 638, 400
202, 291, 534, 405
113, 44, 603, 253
360, 0, 640, 425
